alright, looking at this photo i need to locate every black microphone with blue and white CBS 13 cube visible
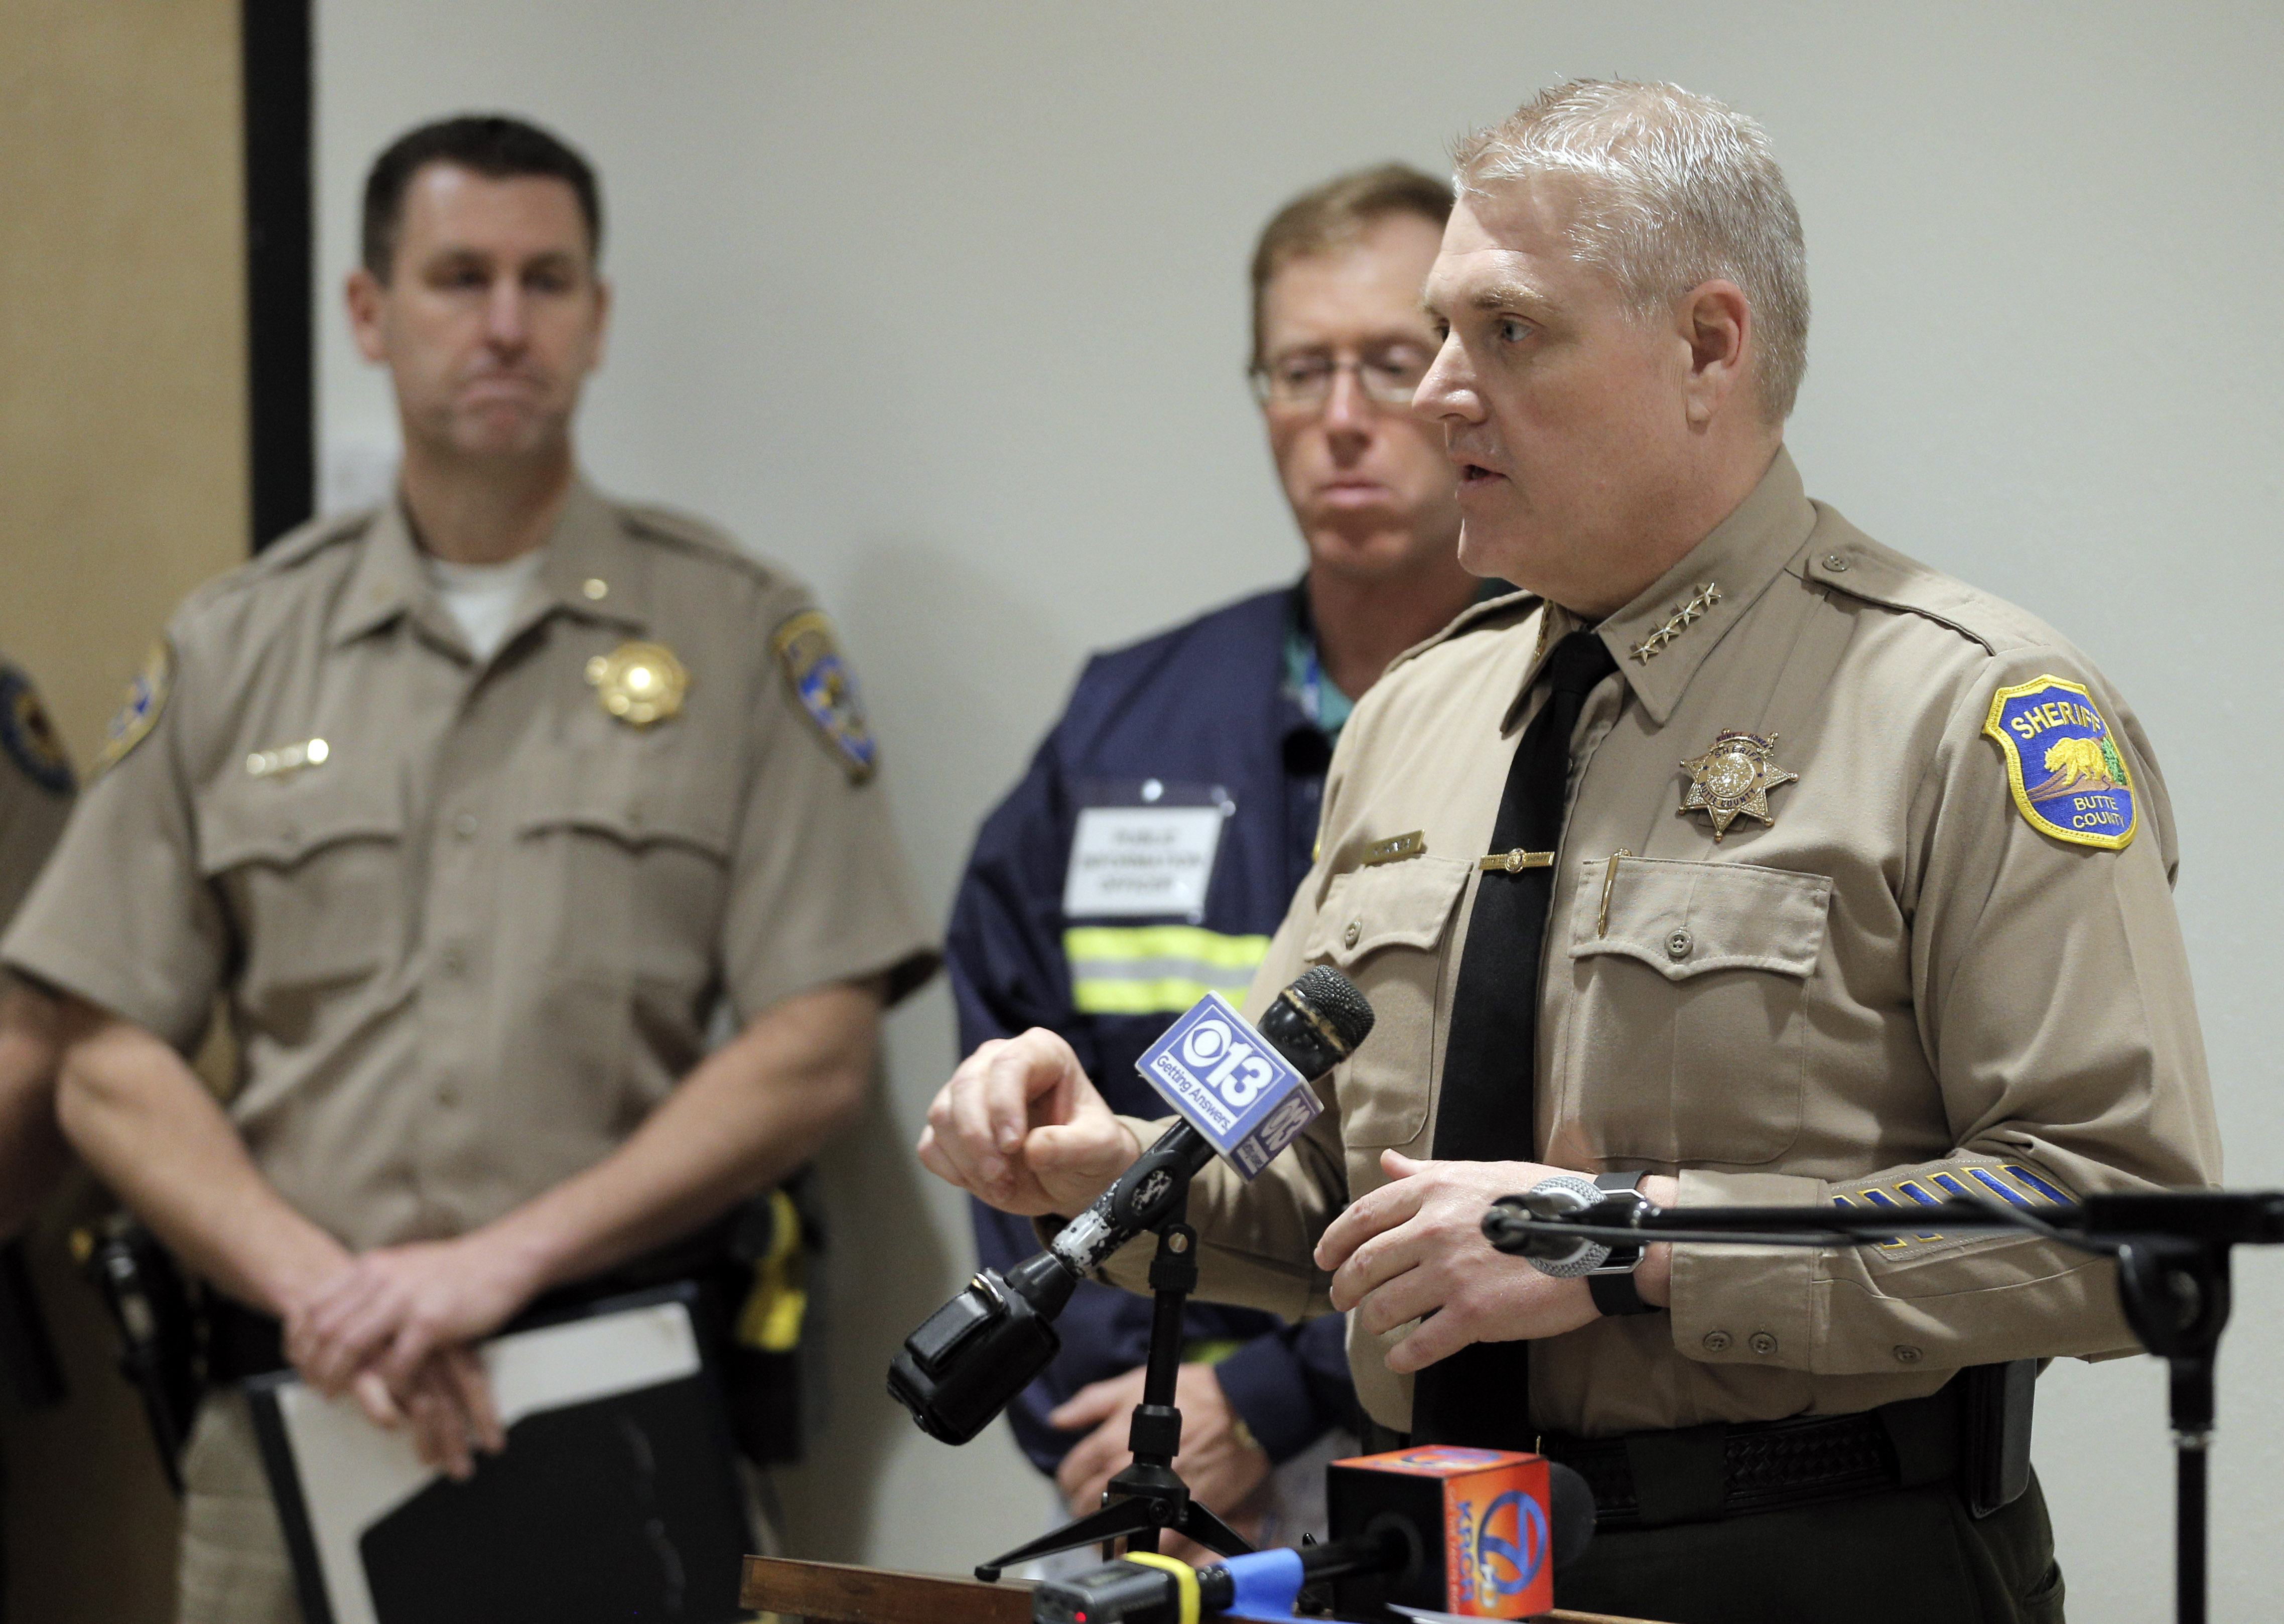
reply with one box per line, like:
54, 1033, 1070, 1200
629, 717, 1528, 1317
888, 964, 1373, 1443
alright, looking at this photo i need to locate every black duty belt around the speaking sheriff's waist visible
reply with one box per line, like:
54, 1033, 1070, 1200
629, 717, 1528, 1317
1539, 1389, 1960, 1528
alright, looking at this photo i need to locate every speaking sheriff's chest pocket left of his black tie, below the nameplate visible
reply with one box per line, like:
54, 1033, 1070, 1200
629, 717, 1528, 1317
1302, 857, 1468, 1151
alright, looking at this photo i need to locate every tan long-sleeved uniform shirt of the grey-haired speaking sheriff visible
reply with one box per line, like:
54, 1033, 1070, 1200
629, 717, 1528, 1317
1115, 452, 2220, 1434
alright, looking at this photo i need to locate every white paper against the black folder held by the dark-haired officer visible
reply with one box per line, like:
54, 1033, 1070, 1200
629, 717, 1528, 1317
277, 1302, 699, 1624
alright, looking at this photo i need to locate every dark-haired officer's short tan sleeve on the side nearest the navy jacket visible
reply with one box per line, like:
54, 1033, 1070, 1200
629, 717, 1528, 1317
722, 598, 936, 1021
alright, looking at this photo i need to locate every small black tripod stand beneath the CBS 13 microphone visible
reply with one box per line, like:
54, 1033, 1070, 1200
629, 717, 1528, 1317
975, 1160, 1252, 1583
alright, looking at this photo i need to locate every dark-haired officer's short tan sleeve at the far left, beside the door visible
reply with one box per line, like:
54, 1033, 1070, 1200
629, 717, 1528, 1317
0, 642, 233, 1053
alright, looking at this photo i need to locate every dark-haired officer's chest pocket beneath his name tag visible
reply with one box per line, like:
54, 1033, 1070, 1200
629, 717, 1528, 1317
196, 765, 405, 996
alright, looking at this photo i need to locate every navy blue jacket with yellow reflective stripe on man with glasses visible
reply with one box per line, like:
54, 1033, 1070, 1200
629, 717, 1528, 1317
946, 587, 1355, 1471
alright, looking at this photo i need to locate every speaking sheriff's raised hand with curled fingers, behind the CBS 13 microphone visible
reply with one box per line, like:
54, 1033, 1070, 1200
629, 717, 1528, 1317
918, 1026, 1142, 1217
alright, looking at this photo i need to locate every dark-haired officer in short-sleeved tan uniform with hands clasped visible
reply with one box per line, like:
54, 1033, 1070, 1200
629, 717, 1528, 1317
5, 119, 932, 1624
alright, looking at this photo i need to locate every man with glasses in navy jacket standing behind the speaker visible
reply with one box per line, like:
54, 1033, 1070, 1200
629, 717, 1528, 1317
948, 165, 1483, 1540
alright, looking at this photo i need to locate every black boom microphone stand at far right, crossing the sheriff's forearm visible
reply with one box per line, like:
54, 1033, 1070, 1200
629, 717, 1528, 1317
1483, 1190, 2284, 1624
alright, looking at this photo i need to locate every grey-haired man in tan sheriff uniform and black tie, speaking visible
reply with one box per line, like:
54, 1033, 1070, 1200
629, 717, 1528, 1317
920, 82, 2218, 1624
